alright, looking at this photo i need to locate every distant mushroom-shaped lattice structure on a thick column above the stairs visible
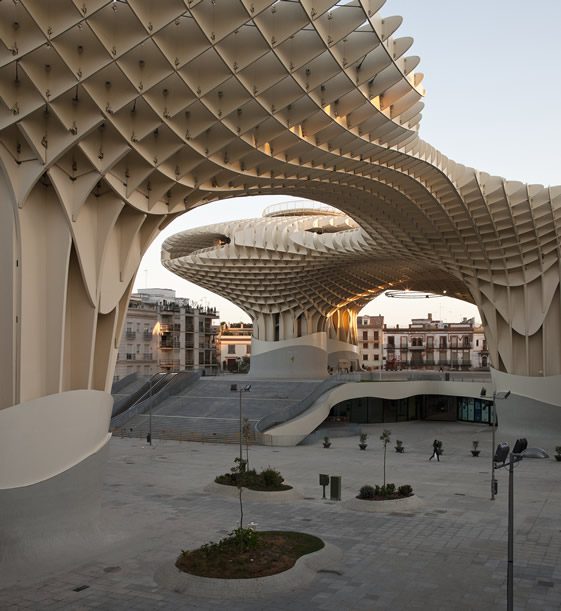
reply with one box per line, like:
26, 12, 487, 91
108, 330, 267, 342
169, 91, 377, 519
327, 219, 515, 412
162, 203, 380, 378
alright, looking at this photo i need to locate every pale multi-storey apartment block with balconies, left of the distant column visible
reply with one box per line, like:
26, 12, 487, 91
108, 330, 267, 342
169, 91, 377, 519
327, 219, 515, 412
115, 289, 219, 380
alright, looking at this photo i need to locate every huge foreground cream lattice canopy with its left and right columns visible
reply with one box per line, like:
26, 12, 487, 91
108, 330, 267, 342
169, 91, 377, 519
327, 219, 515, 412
0, 0, 561, 548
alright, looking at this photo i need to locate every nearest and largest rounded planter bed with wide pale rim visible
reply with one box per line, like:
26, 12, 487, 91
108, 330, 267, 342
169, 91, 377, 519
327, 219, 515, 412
154, 531, 342, 598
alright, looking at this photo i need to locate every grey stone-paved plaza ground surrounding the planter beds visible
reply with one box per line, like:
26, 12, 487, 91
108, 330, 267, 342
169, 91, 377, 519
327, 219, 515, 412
0, 422, 561, 611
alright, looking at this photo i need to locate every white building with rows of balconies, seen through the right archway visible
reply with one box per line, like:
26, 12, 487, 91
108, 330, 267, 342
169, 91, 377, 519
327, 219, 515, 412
384, 314, 489, 370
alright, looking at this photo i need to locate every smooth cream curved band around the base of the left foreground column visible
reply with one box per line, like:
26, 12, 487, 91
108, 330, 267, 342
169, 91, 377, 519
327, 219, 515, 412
0, 390, 113, 490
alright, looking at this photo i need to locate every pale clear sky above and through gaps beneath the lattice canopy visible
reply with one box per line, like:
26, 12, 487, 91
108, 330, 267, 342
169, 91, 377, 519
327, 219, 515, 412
135, 0, 561, 325
